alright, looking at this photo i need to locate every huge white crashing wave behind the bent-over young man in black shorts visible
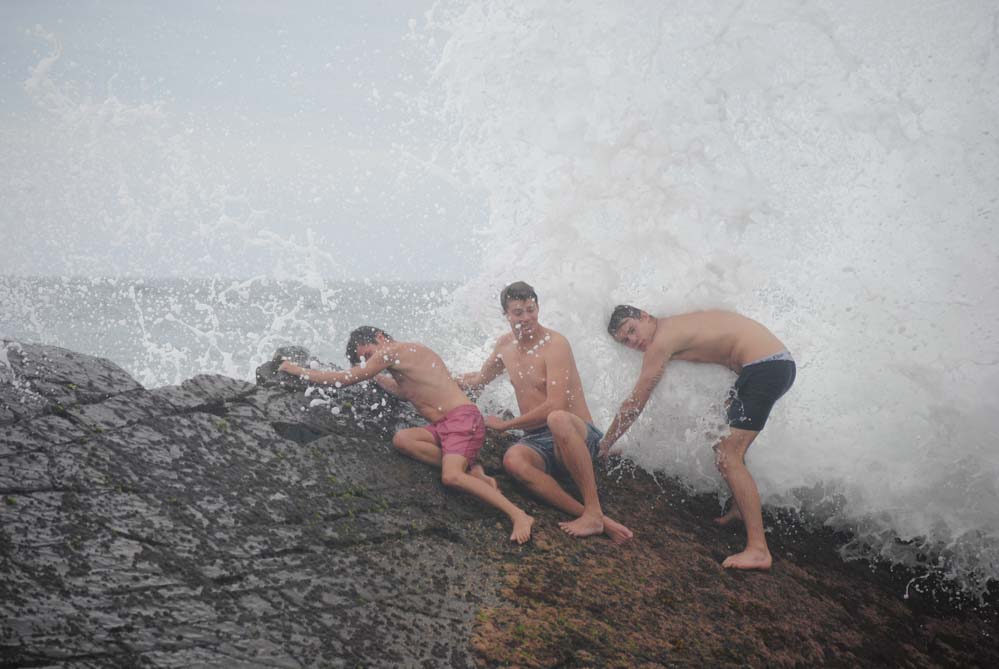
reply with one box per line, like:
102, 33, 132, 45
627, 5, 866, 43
432, 0, 999, 589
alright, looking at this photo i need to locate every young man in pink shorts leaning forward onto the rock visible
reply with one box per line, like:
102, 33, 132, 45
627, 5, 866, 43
279, 325, 534, 544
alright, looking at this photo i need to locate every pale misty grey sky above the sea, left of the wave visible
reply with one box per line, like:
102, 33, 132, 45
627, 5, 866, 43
0, 0, 486, 279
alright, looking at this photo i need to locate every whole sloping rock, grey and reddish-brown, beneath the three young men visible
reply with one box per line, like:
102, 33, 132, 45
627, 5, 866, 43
0, 342, 999, 667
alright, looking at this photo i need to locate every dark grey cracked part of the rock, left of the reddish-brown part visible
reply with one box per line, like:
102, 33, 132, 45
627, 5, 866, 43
0, 342, 499, 667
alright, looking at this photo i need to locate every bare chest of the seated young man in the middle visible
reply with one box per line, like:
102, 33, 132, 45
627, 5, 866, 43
496, 328, 593, 423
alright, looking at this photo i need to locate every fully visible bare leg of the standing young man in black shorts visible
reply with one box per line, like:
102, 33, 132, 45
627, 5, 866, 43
715, 428, 773, 569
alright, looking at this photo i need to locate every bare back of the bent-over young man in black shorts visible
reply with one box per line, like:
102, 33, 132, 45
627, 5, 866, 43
653, 310, 787, 373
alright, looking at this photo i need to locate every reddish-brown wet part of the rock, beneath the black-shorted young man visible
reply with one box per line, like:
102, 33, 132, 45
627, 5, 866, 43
472, 467, 999, 669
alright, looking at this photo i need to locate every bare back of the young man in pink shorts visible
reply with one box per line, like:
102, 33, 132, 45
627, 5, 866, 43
376, 342, 471, 423
